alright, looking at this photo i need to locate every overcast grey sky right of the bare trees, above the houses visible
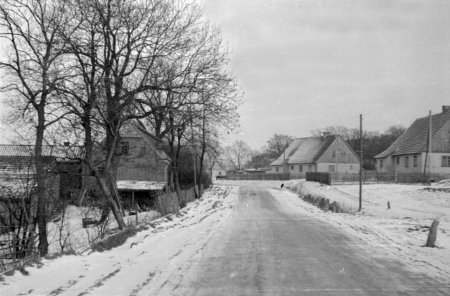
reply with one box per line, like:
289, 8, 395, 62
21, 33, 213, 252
203, 0, 450, 148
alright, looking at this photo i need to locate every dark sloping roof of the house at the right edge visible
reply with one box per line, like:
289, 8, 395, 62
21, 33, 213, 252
375, 112, 450, 158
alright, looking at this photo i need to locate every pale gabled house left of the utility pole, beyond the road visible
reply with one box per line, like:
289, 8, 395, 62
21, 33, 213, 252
270, 135, 359, 174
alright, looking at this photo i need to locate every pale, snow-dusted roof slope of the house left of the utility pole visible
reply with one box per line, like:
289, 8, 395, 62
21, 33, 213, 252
270, 135, 338, 165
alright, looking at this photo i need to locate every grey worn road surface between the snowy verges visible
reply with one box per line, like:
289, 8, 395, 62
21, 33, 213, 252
188, 187, 450, 296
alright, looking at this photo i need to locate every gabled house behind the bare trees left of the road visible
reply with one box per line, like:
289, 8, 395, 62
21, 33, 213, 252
89, 122, 170, 207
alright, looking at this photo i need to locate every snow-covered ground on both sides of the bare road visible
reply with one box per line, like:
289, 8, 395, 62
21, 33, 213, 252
0, 180, 450, 296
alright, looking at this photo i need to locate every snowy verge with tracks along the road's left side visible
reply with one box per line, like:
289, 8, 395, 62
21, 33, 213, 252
0, 186, 237, 296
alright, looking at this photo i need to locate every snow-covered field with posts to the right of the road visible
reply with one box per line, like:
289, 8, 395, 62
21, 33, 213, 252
224, 180, 450, 282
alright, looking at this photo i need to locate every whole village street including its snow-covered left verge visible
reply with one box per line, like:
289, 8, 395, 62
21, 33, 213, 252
0, 186, 450, 295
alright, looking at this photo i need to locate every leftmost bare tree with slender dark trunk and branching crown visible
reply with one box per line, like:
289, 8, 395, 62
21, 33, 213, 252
0, 0, 71, 256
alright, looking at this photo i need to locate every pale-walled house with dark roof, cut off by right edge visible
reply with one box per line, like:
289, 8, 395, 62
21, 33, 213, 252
375, 106, 450, 174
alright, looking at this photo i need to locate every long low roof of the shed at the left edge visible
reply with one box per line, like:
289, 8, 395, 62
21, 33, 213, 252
0, 144, 83, 159
